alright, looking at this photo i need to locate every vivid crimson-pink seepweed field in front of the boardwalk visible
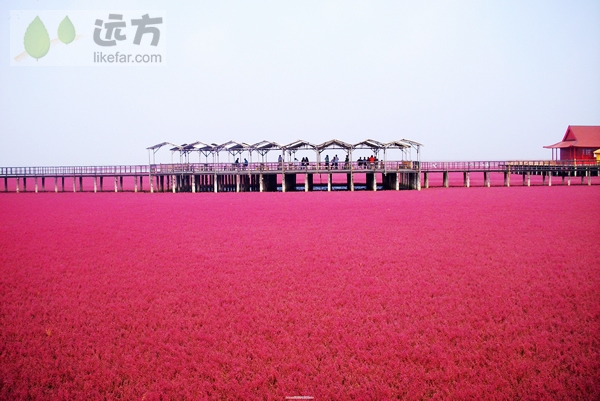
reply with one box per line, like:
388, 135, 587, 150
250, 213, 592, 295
0, 186, 600, 400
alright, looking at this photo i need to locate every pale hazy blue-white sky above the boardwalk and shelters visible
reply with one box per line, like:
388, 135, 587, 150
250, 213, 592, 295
0, 0, 600, 166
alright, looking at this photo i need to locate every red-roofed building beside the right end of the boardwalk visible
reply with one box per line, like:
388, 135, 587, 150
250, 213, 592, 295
544, 125, 600, 160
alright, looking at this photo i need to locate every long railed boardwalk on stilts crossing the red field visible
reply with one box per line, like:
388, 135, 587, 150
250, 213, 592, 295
0, 160, 600, 193
